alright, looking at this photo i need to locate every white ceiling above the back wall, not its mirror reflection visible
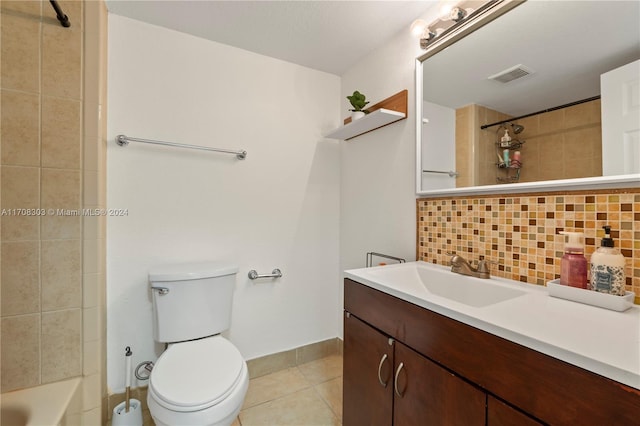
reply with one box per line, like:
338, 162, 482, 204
106, 0, 437, 75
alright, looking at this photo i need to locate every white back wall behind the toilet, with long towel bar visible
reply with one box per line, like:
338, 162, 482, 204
107, 15, 342, 392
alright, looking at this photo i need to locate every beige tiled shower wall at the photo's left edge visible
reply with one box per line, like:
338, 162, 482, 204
0, 1, 106, 423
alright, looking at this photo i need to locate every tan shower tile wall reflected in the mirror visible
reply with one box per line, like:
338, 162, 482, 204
456, 99, 602, 187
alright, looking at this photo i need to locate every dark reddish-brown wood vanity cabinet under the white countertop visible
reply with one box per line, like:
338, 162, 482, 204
343, 279, 640, 426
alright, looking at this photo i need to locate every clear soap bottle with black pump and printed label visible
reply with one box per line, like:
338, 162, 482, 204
590, 226, 626, 296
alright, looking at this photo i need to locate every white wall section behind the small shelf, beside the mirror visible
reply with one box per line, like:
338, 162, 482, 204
340, 13, 435, 269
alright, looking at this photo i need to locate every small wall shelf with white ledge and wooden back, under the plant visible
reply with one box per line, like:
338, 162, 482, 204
325, 90, 408, 140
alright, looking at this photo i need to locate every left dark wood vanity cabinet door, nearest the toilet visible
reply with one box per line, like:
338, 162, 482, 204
342, 314, 393, 426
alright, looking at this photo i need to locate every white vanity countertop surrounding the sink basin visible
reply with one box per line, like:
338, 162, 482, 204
344, 262, 640, 389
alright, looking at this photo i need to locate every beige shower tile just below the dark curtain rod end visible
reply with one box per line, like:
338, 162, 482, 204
42, 23, 82, 99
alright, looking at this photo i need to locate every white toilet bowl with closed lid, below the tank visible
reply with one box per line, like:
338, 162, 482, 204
147, 335, 249, 426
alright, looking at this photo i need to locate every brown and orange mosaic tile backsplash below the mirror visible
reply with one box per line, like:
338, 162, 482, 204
417, 188, 640, 304
